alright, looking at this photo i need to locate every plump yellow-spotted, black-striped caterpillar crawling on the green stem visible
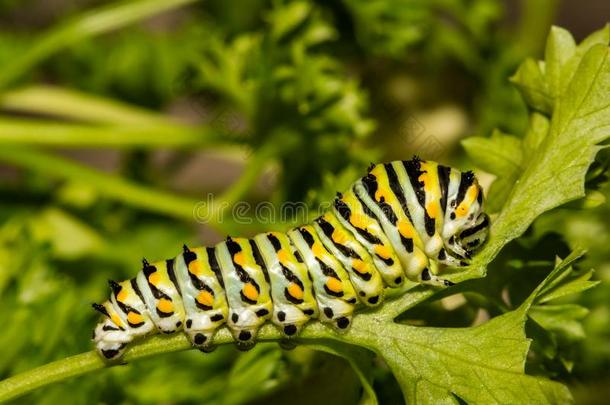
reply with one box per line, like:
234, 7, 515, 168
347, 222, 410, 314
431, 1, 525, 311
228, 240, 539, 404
93, 157, 490, 360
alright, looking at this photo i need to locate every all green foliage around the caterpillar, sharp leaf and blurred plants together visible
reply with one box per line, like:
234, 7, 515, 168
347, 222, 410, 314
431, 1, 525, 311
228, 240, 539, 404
0, 0, 610, 404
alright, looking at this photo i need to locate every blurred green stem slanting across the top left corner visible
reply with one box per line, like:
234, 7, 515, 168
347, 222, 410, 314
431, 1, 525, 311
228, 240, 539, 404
0, 0, 196, 89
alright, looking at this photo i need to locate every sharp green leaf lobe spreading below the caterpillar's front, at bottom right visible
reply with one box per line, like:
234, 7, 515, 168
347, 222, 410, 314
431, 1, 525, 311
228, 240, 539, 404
332, 252, 580, 404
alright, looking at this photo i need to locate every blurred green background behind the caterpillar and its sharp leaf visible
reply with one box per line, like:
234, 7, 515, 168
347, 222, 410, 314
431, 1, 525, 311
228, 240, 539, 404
0, 0, 610, 404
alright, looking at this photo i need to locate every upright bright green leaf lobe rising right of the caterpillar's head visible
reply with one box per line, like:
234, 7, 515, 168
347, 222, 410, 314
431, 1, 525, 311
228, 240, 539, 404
464, 25, 610, 271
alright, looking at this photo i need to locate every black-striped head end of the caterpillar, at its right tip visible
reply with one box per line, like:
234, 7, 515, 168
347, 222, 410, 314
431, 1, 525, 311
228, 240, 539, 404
443, 172, 489, 259
